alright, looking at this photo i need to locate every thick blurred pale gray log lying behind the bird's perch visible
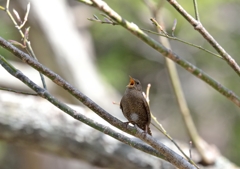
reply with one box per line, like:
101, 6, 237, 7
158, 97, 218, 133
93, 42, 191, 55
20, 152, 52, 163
0, 91, 237, 169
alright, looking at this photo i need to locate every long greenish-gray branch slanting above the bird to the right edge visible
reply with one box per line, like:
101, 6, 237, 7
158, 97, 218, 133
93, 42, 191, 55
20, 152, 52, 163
76, 0, 240, 107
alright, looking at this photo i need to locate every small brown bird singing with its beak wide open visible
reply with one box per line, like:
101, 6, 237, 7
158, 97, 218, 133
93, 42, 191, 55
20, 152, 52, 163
120, 76, 152, 135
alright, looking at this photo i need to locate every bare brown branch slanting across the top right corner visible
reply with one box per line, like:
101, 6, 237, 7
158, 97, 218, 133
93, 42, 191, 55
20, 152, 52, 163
168, 0, 240, 76
